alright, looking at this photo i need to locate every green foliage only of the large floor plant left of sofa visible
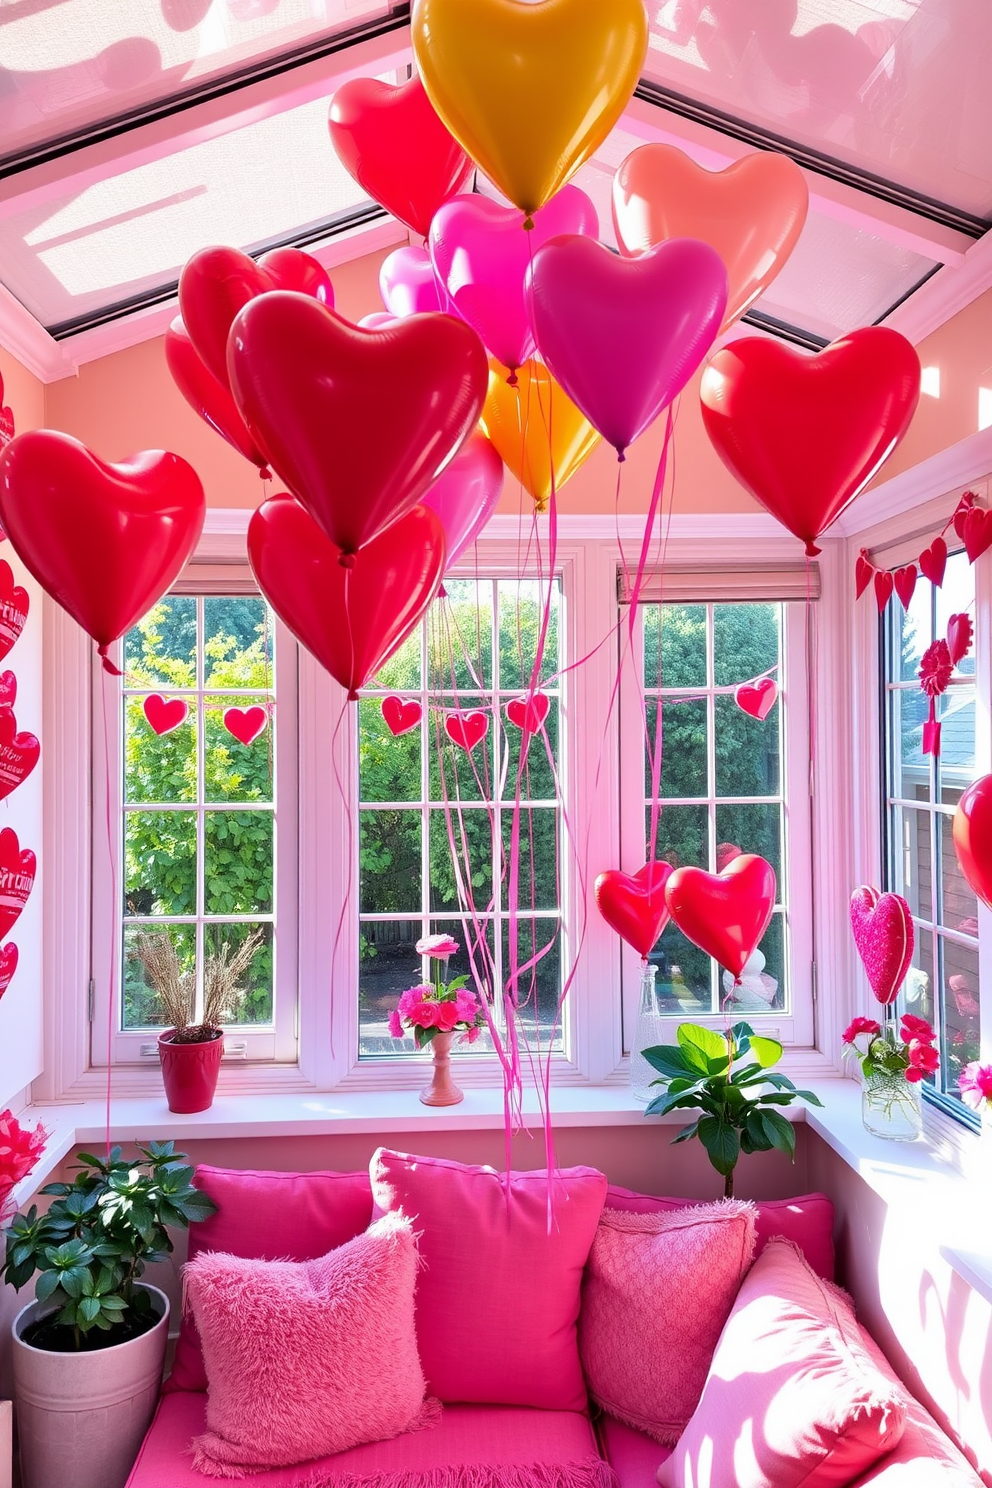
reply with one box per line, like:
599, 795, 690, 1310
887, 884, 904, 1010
0, 1141, 216, 1353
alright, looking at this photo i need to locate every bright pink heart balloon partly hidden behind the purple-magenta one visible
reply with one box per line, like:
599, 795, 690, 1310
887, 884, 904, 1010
428, 186, 599, 369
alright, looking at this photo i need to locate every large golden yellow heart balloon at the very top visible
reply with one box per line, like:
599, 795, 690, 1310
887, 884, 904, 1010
410, 0, 648, 216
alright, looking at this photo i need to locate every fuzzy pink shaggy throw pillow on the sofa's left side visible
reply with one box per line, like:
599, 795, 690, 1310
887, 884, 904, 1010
183, 1214, 437, 1478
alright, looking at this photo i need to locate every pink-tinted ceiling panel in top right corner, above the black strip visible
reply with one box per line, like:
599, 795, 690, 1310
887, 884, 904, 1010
645, 0, 992, 217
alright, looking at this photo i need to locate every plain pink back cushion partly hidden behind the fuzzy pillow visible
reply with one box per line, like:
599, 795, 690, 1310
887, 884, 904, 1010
165, 1164, 372, 1390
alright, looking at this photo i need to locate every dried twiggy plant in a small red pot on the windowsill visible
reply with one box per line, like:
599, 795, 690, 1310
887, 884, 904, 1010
135, 930, 262, 1115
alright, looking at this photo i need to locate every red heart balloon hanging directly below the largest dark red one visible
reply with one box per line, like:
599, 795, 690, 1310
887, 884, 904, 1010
248, 494, 445, 698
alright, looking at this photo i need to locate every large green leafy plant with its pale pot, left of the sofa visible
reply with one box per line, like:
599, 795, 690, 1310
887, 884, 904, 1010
0, 1141, 216, 1488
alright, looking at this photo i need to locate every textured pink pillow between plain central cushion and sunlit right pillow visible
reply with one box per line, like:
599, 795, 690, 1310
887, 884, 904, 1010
579, 1199, 754, 1445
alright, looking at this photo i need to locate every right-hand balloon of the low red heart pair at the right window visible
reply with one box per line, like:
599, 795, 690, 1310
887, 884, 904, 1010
665, 853, 775, 976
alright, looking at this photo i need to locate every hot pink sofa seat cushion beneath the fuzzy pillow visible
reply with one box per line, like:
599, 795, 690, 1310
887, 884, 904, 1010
128, 1391, 616, 1488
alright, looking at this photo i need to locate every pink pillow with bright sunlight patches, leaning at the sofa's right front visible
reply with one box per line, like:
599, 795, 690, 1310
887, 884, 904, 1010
657, 1240, 910, 1488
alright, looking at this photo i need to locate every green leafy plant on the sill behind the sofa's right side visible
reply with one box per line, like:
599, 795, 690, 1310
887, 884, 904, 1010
644, 1022, 822, 1198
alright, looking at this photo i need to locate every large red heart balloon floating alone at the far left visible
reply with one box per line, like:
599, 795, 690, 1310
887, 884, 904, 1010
0, 429, 207, 661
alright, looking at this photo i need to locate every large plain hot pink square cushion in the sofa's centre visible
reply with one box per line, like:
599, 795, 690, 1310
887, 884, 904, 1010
370, 1147, 607, 1411
